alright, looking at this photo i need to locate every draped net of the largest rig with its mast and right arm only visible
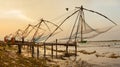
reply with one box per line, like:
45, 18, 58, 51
57, 7, 116, 41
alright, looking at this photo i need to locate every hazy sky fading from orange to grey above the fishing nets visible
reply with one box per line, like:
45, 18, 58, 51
0, 0, 120, 39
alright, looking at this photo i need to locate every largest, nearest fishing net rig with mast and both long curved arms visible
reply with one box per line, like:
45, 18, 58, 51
45, 6, 117, 42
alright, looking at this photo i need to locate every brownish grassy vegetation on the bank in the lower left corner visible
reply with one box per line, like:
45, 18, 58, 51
0, 46, 59, 67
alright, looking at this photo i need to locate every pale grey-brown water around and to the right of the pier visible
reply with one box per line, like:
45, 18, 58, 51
21, 42, 120, 67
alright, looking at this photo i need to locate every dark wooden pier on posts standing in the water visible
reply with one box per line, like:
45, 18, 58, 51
3, 40, 77, 58
